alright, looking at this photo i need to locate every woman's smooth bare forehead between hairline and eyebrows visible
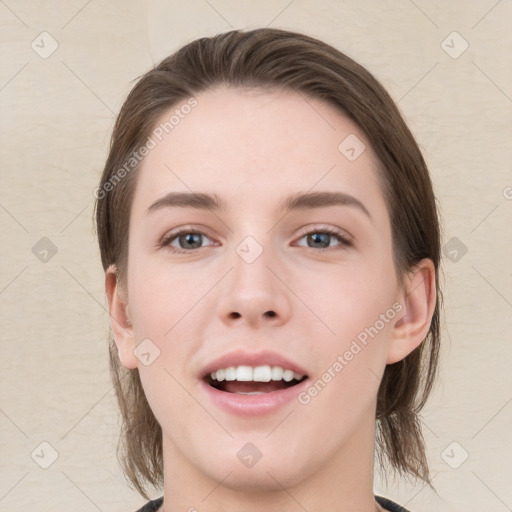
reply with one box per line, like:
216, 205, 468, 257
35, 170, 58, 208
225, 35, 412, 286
133, 86, 381, 216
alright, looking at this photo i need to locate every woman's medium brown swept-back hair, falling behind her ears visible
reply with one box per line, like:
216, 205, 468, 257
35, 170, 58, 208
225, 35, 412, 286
95, 28, 441, 498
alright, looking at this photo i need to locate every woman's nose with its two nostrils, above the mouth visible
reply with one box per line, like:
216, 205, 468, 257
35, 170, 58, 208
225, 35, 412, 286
213, 239, 291, 327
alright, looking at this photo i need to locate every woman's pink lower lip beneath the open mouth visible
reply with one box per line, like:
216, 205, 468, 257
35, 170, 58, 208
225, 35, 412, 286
202, 379, 309, 416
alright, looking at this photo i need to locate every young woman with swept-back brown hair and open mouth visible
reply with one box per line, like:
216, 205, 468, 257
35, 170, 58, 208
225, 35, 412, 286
95, 28, 441, 512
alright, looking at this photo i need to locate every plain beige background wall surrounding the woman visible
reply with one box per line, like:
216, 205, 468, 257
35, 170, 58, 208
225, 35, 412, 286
0, 0, 512, 512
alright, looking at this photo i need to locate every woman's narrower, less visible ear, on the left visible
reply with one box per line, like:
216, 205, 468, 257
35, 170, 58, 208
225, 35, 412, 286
105, 265, 138, 370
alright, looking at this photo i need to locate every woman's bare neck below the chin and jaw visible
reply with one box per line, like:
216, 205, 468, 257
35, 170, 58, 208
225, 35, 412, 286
162, 412, 383, 512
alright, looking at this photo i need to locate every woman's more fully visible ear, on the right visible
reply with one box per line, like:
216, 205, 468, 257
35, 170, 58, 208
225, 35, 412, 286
386, 259, 436, 364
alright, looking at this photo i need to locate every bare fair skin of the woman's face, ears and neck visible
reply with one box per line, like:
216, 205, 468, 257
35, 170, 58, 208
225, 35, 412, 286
106, 87, 435, 512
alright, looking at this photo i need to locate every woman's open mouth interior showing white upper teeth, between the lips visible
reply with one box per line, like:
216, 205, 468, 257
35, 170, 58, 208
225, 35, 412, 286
204, 366, 308, 395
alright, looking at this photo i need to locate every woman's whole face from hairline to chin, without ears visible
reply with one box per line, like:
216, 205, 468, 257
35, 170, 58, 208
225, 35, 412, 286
115, 88, 402, 489
